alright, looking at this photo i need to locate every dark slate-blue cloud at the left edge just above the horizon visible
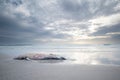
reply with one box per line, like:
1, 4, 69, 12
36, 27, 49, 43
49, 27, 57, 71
0, 15, 34, 45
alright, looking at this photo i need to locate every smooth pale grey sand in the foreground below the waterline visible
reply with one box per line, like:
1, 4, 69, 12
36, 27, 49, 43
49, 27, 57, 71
0, 59, 120, 80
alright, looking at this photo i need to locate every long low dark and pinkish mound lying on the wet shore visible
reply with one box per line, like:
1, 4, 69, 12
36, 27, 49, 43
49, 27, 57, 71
14, 54, 66, 60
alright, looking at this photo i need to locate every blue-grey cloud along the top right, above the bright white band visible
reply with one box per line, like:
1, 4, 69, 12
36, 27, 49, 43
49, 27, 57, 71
60, 0, 118, 20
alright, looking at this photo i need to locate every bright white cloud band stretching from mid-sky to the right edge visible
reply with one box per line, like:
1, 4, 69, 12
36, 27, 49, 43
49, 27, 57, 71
46, 14, 120, 40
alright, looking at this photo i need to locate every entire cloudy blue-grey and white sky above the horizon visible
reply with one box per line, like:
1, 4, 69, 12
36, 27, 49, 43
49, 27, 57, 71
0, 0, 120, 45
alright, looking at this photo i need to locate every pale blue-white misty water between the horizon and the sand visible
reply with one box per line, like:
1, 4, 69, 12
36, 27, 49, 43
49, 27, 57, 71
0, 44, 120, 65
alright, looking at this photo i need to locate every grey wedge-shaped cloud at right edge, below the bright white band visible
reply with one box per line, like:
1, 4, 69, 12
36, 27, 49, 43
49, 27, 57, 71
89, 24, 120, 43
